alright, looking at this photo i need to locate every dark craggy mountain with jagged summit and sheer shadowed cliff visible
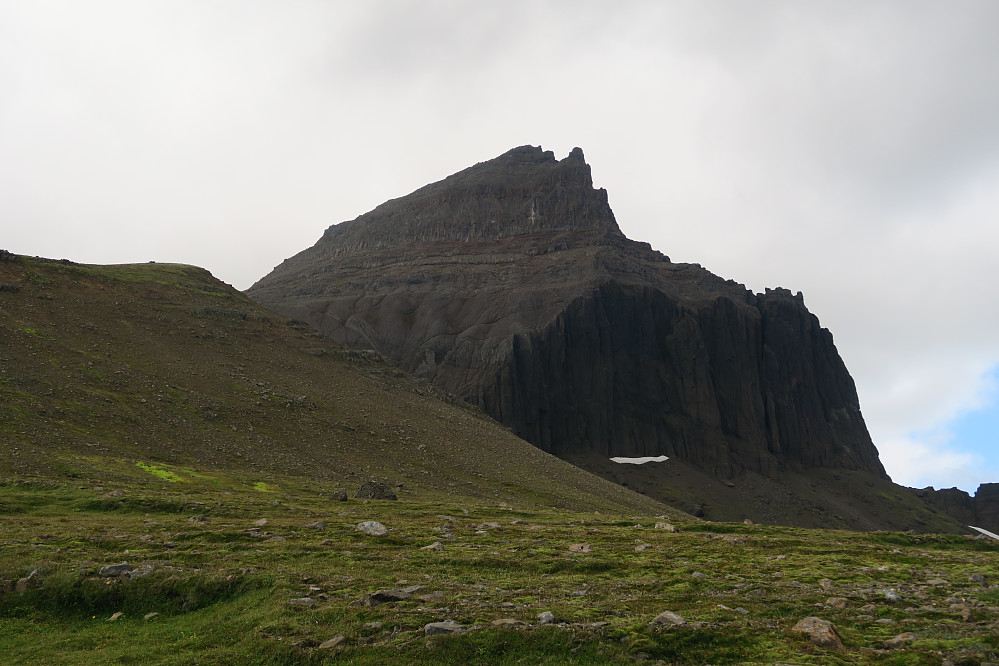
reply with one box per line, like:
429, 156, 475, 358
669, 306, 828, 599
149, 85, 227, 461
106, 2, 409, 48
247, 146, 980, 529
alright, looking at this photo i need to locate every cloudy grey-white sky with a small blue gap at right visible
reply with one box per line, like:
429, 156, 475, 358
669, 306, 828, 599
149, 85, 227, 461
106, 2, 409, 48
0, 0, 999, 492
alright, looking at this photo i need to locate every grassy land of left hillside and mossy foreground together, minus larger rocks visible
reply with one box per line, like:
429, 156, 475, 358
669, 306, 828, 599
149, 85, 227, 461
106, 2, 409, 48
0, 253, 999, 664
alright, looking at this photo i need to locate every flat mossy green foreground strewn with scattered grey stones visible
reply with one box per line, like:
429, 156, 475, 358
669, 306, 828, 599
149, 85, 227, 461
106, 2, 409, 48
0, 470, 999, 664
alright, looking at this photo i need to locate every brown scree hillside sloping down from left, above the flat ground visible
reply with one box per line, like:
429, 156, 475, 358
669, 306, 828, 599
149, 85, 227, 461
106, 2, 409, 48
0, 251, 678, 515
